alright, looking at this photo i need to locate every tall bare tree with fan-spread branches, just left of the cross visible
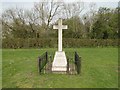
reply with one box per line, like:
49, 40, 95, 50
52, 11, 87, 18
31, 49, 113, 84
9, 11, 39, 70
35, 0, 62, 30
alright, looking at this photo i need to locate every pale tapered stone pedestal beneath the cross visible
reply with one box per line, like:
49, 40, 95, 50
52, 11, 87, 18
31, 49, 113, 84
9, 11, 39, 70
52, 51, 67, 72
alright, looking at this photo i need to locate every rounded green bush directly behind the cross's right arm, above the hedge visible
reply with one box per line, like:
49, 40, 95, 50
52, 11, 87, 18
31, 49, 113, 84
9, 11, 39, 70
63, 16, 84, 38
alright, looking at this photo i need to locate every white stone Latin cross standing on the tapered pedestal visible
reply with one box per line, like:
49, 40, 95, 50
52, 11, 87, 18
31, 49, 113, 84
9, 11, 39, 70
53, 19, 67, 51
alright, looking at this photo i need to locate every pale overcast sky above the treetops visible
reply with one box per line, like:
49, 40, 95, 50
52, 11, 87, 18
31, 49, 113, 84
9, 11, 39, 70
0, 0, 119, 11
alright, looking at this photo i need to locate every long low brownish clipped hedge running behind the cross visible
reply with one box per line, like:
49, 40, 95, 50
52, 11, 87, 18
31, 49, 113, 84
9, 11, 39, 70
2, 38, 118, 48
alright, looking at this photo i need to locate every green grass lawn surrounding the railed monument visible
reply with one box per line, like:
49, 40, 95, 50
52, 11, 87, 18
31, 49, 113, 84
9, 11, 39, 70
2, 47, 118, 88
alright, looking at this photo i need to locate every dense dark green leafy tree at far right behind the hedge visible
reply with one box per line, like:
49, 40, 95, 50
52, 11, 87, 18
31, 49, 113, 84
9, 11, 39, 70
91, 8, 118, 39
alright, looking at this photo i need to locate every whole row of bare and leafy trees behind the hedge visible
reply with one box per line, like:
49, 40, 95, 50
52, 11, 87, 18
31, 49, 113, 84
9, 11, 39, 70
0, 2, 120, 39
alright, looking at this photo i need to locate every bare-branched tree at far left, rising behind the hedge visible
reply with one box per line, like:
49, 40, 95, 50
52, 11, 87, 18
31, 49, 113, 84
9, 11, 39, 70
2, 8, 27, 36
